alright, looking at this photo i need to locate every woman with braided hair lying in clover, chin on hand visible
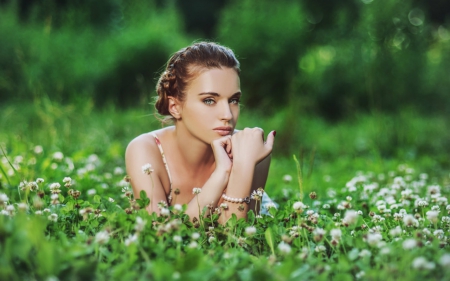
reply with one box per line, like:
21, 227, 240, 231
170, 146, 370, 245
125, 42, 276, 223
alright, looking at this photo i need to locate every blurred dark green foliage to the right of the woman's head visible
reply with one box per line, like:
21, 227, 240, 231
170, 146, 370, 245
218, 0, 450, 119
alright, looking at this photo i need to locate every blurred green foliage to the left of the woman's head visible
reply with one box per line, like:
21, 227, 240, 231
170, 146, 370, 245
0, 1, 189, 106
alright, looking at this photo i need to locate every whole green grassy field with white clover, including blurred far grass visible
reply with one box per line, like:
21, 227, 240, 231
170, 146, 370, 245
0, 100, 450, 280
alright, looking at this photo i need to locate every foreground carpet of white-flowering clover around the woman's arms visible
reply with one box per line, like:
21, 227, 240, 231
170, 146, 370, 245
0, 146, 450, 280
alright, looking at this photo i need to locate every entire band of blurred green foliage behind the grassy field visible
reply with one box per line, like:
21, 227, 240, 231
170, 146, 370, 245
0, 0, 450, 116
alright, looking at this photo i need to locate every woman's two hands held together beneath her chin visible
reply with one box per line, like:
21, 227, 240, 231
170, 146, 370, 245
211, 128, 275, 173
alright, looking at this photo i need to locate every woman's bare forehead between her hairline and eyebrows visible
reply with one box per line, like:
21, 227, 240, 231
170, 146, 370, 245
186, 68, 240, 95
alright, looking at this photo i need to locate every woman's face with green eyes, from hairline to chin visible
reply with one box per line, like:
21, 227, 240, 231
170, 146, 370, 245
180, 68, 241, 144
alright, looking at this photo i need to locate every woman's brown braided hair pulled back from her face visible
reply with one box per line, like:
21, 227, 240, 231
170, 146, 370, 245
155, 42, 240, 119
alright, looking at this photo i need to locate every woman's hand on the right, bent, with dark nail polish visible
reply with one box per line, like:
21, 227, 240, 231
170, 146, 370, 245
231, 128, 275, 165
